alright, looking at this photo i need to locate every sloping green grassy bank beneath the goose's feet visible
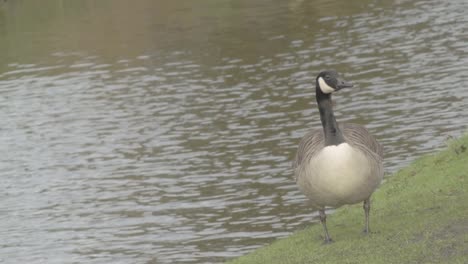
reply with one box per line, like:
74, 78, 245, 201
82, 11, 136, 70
231, 135, 468, 264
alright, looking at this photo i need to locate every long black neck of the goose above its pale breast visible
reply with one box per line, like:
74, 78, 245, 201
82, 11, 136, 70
316, 83, 344, 146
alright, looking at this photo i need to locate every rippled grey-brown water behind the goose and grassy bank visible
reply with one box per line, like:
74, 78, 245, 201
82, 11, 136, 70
0, 0, 468, 263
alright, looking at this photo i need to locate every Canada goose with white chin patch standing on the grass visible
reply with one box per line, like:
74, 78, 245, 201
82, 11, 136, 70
293, 71, 383, 243
